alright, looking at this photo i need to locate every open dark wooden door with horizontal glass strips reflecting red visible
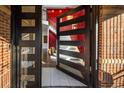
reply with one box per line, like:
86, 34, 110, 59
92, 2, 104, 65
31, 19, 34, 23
57, 6, 90, 86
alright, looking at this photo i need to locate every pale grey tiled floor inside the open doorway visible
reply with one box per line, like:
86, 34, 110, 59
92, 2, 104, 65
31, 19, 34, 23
42, 67, 86, 87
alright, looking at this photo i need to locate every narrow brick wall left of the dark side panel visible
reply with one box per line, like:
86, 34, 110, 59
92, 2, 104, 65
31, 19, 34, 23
0, 10, 10, 88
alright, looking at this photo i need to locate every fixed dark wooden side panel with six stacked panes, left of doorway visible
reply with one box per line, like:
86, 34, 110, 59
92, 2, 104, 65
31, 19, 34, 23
12, 6, 42, 88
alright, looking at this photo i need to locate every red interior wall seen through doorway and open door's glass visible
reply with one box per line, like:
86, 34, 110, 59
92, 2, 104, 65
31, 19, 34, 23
48, 9, 85, 52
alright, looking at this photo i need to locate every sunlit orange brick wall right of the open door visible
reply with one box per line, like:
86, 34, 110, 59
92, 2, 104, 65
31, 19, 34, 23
98, 6, 124, 87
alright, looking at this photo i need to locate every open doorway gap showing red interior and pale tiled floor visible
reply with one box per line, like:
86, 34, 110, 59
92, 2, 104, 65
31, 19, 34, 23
42, 6, 87, 87
